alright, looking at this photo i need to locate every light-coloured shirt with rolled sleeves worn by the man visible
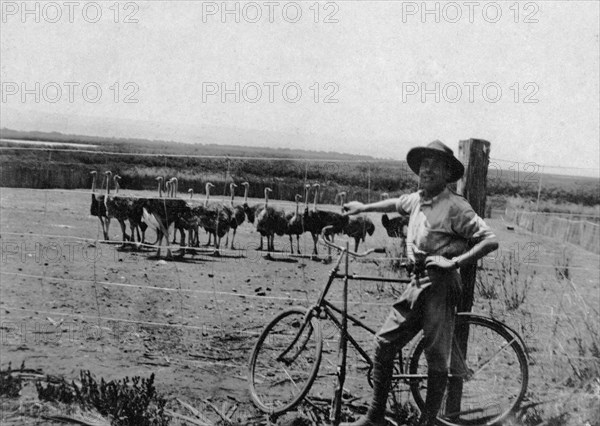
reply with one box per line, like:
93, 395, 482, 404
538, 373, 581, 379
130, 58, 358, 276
396, 188, 494, 261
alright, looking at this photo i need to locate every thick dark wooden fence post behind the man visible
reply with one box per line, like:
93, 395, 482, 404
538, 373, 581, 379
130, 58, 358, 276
445, 139, 490, 417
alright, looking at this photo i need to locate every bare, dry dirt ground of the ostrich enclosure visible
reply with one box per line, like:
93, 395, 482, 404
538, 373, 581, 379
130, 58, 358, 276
0, 188, 600, 424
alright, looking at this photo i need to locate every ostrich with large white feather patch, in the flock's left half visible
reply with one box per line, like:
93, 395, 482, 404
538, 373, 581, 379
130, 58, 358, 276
142, 177, 189, 259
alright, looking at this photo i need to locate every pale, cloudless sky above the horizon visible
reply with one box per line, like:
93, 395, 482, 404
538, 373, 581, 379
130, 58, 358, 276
0, 0, 600, 176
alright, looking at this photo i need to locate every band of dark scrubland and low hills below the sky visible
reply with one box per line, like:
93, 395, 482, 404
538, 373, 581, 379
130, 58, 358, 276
0, 128, 600, 206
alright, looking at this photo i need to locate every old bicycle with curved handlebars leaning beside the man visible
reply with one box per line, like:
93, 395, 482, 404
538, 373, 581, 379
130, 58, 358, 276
248, 229, 528, 426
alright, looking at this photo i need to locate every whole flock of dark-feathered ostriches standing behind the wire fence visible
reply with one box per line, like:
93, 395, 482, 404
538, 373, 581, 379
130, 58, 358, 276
90, 171, 408, 258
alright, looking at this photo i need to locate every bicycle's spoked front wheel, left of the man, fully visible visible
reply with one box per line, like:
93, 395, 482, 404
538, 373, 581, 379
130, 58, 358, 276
248, 308, 323, 414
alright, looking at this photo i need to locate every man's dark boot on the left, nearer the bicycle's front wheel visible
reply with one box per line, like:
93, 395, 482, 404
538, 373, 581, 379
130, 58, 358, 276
340, 341, 396, 426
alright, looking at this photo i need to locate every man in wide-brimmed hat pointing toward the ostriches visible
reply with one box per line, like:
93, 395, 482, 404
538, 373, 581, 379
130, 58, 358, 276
344, 140, 498, 426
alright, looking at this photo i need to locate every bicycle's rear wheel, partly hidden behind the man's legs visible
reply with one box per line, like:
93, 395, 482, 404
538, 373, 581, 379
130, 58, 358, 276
409, 314, 528, 426
